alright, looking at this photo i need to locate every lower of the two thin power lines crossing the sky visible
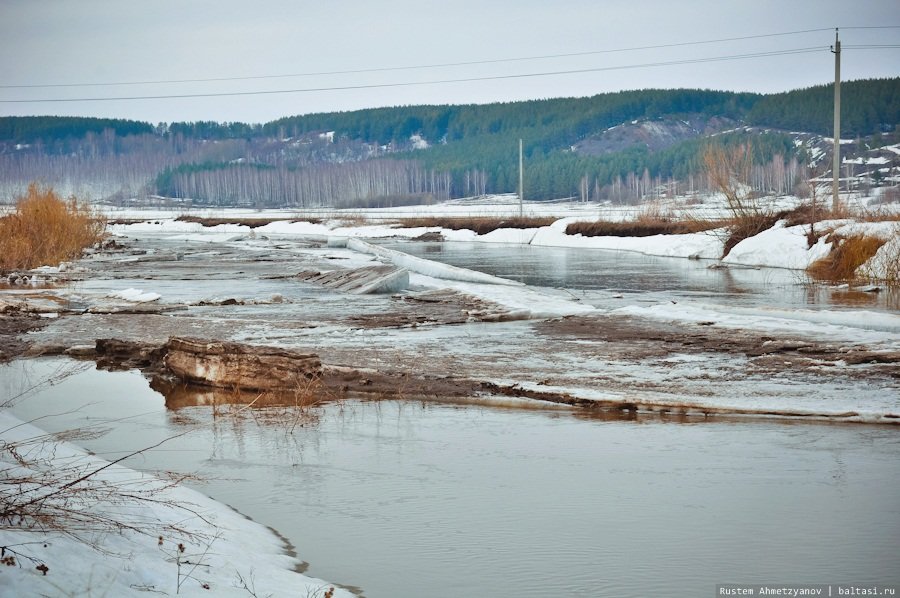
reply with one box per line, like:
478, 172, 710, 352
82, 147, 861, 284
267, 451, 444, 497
0, 46, 828, 104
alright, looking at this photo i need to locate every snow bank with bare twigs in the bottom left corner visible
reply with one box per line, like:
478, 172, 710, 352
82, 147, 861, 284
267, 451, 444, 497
0, 412, 351, 598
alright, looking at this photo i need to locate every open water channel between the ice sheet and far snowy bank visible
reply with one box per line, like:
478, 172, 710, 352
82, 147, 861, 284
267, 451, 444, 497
386, 242, 900, 310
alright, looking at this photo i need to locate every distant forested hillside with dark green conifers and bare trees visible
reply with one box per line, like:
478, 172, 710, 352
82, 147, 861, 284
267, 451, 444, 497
0, 78, 900, 206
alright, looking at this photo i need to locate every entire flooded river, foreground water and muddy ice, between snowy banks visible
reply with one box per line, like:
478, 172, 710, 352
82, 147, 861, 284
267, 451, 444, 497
0, 229, 900, 598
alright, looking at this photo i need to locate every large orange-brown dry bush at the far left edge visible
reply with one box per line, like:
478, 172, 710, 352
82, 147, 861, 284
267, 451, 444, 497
0, 183, 106, 270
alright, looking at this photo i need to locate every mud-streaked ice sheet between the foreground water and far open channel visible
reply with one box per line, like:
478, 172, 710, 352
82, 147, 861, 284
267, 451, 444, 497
0, 239, 900, 422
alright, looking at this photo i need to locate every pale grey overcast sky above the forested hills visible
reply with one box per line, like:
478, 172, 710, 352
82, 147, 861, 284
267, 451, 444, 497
0, 0, 900, 123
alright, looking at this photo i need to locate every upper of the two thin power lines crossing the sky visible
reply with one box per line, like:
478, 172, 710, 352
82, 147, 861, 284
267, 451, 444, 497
0, 26, 844, 89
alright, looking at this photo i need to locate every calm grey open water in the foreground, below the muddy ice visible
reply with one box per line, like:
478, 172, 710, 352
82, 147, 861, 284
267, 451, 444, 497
0, 360, 900, 598
